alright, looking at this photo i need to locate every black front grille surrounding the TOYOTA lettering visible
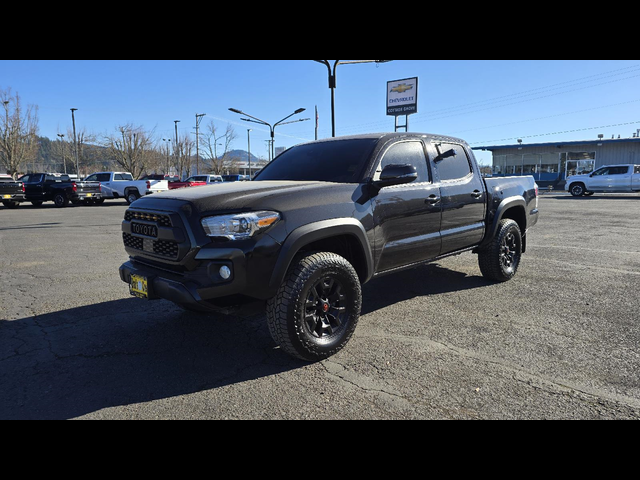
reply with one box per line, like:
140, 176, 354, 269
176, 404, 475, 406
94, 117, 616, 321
122, 210, 184, 260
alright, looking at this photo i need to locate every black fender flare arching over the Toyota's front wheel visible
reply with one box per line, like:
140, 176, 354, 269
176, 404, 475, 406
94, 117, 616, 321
269, 218, 373, 290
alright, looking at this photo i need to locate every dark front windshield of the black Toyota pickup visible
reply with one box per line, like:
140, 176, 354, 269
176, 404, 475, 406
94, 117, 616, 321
254, 138, 377, 183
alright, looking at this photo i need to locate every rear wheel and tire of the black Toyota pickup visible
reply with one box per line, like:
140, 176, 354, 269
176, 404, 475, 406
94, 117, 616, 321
478, 218, 522, 282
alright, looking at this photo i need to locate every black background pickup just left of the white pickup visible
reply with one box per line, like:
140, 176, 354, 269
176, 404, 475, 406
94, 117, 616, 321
19, 173, 104, 207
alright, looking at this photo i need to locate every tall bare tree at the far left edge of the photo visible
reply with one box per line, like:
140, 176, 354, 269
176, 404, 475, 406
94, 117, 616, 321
0, 88, 38, 179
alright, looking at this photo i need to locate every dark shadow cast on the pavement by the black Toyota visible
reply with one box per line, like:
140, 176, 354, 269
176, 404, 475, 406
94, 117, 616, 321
0, 265, 490, 420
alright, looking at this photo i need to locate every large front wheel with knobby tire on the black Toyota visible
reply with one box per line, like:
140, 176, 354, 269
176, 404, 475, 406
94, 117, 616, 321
267, 252, 362, 362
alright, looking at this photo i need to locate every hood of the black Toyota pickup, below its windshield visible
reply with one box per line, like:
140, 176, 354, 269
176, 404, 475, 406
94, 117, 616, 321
136, 180, 359, 214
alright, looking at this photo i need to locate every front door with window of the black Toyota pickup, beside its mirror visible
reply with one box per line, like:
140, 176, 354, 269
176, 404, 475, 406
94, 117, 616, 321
371, 139, 440, 272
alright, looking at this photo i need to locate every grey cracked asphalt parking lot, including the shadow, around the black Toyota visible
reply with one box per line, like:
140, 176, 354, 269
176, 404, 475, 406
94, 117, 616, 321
0, 193, 640, 419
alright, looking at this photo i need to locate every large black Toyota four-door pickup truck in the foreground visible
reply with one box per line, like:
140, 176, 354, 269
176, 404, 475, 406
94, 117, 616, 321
120, 133, 538, 361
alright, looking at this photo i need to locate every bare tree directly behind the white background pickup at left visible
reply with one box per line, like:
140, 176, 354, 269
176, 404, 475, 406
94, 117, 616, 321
104, 124, 153, 179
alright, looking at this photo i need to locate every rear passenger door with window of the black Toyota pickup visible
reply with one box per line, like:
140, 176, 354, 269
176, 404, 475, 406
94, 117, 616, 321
429, 141, 486, 254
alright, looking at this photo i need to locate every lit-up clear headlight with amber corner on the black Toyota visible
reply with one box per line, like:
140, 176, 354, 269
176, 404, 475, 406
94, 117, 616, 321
201, 212, 280, 240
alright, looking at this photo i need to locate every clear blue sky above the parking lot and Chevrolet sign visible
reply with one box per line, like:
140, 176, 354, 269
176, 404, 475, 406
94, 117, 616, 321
0, 60, 640, 163
